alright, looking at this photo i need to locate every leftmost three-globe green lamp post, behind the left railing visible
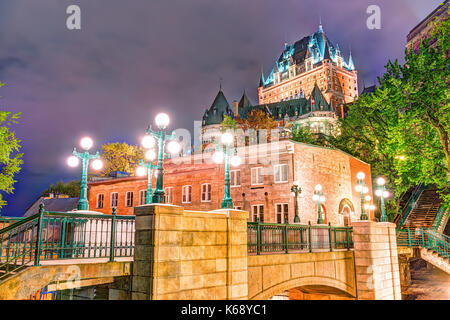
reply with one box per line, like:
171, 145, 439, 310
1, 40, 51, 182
67, 137, 103, 210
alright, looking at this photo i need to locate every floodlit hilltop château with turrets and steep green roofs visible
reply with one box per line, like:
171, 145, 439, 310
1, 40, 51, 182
202, 24, 358, 146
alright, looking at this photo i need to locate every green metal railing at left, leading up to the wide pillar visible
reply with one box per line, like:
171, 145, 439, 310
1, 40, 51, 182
0, 206, 135, 280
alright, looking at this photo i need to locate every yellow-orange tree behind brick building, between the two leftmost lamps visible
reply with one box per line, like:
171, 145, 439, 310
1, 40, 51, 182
102, 142, 144, 176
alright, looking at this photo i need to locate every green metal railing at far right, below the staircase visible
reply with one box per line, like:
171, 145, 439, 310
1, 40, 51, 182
397, 228, 450, 259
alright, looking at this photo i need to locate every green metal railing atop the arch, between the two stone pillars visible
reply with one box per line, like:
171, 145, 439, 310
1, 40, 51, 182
247, 219, 353, 255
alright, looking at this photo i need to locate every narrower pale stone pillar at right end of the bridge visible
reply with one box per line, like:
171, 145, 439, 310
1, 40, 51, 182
352, 221, 402, 300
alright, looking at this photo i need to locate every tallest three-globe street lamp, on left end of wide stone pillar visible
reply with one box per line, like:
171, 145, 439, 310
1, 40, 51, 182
142, 113, 181, 203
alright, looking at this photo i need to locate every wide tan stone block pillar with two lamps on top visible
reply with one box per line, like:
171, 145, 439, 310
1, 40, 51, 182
132, 204, 248, 300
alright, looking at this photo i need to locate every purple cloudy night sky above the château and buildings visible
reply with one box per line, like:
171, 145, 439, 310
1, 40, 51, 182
0, 0, 441, 215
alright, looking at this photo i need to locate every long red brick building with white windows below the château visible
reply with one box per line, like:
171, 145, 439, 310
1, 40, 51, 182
89, 140, 374, 225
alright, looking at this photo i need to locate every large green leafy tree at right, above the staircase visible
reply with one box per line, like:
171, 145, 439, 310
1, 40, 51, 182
329, 16, 450, 218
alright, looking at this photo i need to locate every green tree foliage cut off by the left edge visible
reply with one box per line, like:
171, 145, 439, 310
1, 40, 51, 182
0, 82, 23, 209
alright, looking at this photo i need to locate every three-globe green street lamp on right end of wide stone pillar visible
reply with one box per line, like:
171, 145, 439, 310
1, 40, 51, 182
212, 132, 241, 209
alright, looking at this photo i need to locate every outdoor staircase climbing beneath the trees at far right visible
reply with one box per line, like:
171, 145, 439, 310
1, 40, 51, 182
394, 184, 442, 229
